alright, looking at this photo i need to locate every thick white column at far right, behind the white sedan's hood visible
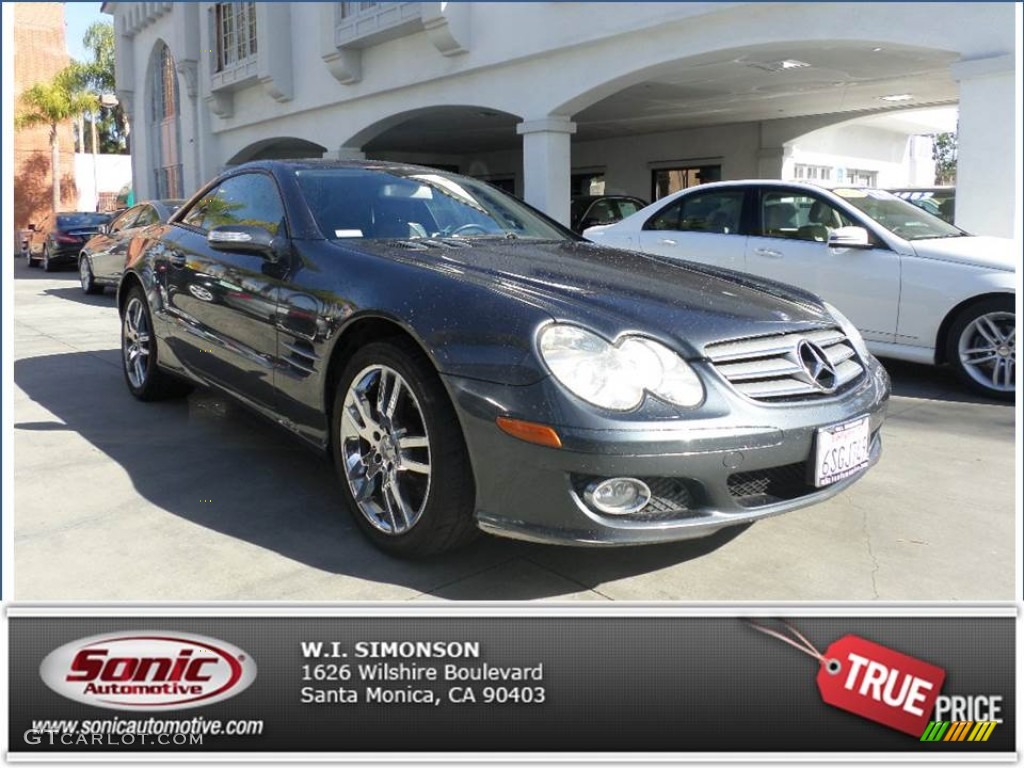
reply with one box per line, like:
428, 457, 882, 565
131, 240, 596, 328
951, 55, 1021, 238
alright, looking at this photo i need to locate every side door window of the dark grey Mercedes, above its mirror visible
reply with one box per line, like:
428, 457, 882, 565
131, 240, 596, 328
182, 173, 285, 234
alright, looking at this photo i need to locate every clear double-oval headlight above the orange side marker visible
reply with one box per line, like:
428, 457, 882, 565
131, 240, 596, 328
540, 325, 703, 411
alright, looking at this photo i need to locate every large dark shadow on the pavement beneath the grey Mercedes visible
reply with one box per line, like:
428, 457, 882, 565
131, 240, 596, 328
14, 350, 749, 600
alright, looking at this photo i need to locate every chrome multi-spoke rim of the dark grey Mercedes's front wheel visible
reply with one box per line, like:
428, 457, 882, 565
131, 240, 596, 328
339, 365, 430, 536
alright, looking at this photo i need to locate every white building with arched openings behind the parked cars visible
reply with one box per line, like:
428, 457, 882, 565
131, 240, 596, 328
103, 2, 1021, 236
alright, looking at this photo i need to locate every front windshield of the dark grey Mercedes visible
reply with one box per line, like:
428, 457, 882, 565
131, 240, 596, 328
296, 168, 570, 240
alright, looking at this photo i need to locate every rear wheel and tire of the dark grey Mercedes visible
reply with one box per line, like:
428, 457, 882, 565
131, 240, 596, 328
121, 286, 191, 401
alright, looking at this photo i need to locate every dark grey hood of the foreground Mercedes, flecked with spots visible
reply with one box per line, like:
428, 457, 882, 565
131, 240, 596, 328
359, 238, 835, 358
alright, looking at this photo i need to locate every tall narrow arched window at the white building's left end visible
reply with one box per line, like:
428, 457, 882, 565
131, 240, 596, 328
150, 45, 184, 198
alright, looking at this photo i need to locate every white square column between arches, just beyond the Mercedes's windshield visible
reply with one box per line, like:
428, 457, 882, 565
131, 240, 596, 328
516, 117, 575, 225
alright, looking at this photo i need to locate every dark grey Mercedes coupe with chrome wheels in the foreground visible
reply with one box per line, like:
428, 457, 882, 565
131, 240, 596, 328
118, 161, 889, 556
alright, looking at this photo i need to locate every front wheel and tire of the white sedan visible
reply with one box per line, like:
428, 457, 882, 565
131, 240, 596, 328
946, 296, 1017, 400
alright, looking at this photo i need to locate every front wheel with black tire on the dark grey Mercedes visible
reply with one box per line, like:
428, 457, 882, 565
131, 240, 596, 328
331, 339, 478, 558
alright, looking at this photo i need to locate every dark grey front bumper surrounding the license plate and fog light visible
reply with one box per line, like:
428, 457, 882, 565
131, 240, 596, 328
445, 359, 889, 545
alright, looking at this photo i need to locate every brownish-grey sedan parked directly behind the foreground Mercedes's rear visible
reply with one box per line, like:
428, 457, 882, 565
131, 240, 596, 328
78, 200, 184, 294
